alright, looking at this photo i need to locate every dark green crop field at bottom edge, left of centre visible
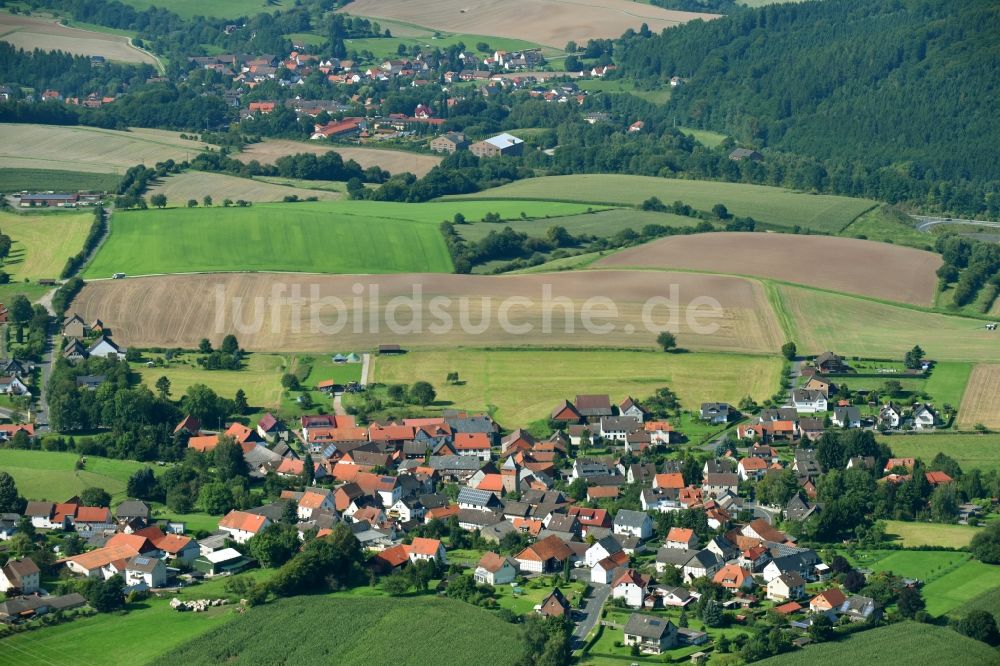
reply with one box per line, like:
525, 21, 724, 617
153, 595, 521, 666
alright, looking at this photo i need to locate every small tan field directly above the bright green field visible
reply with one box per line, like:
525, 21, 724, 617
147, 171, 340, 206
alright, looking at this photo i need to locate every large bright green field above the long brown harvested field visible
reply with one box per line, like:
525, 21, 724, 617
87, 201, 586, 277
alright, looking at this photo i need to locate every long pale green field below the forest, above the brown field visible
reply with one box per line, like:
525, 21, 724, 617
448, 174, 875, 233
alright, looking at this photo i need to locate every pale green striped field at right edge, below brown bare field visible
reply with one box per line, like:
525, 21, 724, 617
771, 285, 1000, 361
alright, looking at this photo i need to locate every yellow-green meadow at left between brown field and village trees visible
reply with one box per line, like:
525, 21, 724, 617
132, 354, 288, 412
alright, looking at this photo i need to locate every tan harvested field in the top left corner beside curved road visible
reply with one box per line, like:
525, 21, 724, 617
0, 13, 157, 67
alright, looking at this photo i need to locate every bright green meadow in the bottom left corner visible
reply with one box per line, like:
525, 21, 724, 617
0, 588, 237, 666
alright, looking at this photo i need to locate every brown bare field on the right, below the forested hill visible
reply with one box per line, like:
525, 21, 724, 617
595, 233, 941, 305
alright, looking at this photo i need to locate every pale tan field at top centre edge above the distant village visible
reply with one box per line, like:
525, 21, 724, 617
343, 0, 716, 48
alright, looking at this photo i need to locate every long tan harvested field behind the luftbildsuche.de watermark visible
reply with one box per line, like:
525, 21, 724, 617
73, 271, 784, 352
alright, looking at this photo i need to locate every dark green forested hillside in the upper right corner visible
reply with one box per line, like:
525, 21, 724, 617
616, 0, 1000, 213
